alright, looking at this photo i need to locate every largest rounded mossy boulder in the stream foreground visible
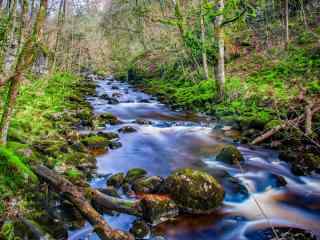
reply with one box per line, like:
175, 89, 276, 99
162, 168, 224, 214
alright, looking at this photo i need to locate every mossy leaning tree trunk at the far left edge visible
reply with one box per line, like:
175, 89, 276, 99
0, 0, 48, 145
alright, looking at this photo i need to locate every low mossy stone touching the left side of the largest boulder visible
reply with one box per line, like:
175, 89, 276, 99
132, 176, 163, 193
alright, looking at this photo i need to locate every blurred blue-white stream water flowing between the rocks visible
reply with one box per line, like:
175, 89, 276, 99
69, 78, 320, 240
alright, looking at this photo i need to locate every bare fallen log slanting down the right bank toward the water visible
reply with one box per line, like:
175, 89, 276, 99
251, 106, 320, 145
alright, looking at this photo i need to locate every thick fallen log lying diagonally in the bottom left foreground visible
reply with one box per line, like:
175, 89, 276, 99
33, 166, 134, 240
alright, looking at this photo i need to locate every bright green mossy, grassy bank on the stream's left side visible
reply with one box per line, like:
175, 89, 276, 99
0, 72, 95, 236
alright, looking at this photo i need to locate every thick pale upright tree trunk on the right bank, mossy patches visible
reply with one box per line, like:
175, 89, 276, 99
214, 0, 225, 100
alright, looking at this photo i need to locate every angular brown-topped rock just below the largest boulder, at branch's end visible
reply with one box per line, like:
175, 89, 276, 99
141, 194, 179, 225
